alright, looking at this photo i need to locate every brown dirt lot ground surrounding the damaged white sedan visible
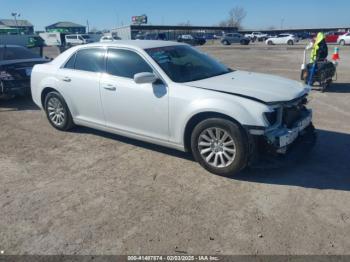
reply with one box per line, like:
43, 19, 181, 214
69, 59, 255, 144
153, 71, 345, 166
0, 42, 350, 254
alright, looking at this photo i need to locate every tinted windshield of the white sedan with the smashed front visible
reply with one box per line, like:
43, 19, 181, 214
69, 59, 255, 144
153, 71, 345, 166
146, 45, 232, 83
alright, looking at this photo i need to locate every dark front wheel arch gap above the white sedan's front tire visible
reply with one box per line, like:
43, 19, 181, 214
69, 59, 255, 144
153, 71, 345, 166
183, 111, 245, 152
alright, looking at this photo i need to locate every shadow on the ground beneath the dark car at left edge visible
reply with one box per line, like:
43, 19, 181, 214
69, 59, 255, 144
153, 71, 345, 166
0, 96, 40, 113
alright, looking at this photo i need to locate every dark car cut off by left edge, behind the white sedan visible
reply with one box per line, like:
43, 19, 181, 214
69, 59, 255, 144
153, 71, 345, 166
0, 45, 50, 97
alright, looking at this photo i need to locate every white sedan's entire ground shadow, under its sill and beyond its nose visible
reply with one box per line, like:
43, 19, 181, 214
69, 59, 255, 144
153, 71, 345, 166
72, 127, 350, 191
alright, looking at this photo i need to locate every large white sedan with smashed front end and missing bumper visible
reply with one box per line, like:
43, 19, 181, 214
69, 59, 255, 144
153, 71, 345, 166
31, 40, 313, 175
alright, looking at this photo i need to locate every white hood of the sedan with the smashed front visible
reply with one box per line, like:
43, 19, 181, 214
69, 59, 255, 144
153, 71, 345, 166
185, 71, 310, 103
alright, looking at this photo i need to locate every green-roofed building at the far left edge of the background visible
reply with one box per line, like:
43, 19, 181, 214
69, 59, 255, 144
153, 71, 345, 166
0, 19, 34, 35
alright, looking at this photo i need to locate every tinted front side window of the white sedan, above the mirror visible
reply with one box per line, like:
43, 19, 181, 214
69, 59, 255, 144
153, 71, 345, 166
107, 49, 153, 78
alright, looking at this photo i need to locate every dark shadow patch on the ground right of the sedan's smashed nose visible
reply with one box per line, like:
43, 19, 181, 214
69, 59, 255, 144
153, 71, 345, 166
235, 130, 350, 191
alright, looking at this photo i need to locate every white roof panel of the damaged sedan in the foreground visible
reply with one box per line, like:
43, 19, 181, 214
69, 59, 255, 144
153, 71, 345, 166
84, 40, 185, 49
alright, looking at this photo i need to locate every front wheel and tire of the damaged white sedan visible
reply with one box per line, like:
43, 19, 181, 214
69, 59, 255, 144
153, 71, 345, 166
191, 118, 249, 176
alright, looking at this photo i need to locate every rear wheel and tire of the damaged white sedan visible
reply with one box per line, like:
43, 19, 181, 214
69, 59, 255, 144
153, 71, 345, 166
44, 91, 74, 131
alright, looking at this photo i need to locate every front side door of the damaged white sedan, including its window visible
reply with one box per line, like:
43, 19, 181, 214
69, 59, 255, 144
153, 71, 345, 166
101, 48, 169, 141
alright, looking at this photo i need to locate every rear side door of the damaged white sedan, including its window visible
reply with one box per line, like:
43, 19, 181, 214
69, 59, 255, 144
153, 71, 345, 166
57, 48, 106, 126
